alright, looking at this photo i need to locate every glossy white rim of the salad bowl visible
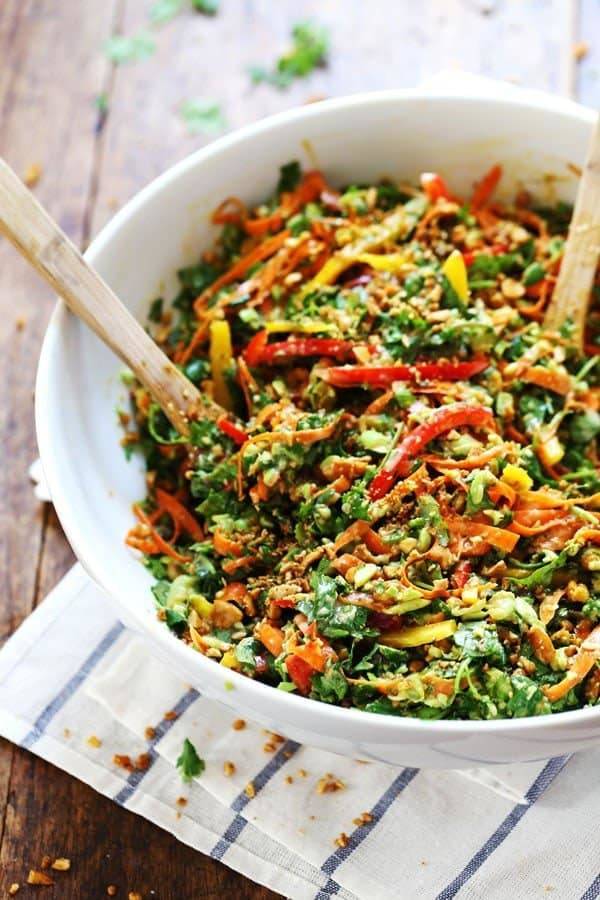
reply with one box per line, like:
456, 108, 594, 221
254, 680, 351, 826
35, 84, 600, 743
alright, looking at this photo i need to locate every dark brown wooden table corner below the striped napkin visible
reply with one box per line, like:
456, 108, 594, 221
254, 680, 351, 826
0, 754, 276, 900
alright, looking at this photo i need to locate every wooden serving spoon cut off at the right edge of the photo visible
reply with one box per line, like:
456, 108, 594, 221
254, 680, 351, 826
544, 117, 600, 351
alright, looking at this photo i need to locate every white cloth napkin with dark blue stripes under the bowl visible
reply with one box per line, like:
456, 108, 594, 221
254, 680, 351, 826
0, 565, 600, 900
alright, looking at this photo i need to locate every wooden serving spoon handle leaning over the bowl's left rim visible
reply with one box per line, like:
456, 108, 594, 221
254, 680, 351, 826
0, 158, 226, 436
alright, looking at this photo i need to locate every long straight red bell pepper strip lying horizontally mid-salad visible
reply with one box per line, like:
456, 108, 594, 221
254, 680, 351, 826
322, 356, 489, 387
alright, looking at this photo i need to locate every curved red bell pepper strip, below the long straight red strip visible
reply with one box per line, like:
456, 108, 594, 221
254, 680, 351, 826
369, 403, 494, 500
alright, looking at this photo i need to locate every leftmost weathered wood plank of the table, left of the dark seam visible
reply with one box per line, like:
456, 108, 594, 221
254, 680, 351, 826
0, 0, 118, 892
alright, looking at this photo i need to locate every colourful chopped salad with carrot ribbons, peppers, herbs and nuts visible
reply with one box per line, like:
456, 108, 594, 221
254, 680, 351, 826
121, 162, 600, 719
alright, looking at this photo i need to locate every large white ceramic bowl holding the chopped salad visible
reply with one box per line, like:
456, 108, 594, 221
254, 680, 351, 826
36, 91, 600, 768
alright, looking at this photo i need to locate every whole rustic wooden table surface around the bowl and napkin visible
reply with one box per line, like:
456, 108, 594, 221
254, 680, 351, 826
0, 0, 600, 900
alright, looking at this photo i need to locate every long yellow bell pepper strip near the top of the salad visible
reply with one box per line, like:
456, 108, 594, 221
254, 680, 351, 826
302, 197, 426, 294
